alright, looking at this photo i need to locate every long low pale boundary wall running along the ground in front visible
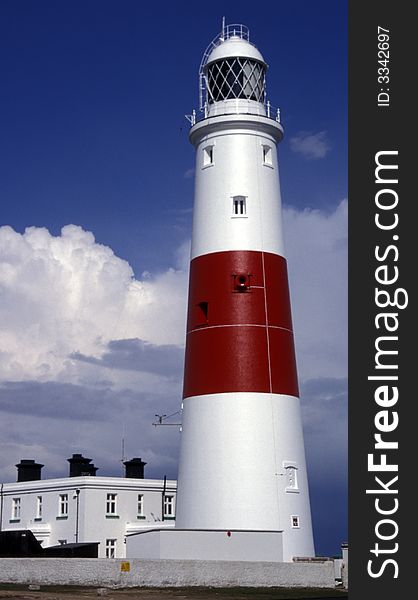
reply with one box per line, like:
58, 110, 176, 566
0, 558, 335, 588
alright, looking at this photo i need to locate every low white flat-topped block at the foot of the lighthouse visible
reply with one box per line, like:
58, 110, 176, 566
126, 528, 283, 562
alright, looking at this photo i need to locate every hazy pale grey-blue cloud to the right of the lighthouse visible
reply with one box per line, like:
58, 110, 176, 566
284, 201, 348, 379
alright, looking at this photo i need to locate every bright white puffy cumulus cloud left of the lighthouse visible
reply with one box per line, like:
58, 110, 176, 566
0, 225, 187, 380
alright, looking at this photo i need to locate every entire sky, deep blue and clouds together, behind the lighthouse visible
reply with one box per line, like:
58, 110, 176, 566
0, 0, 347, 554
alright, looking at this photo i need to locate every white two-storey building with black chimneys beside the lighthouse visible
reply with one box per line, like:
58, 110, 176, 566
0, 455, 177, 558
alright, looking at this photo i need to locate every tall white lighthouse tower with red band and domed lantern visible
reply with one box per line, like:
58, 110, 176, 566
176, 25, 314, 561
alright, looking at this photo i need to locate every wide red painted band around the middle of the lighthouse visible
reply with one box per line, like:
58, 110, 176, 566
183, 251, 298, 398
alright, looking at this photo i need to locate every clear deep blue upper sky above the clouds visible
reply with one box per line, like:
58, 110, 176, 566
0, 0, 347, 270
